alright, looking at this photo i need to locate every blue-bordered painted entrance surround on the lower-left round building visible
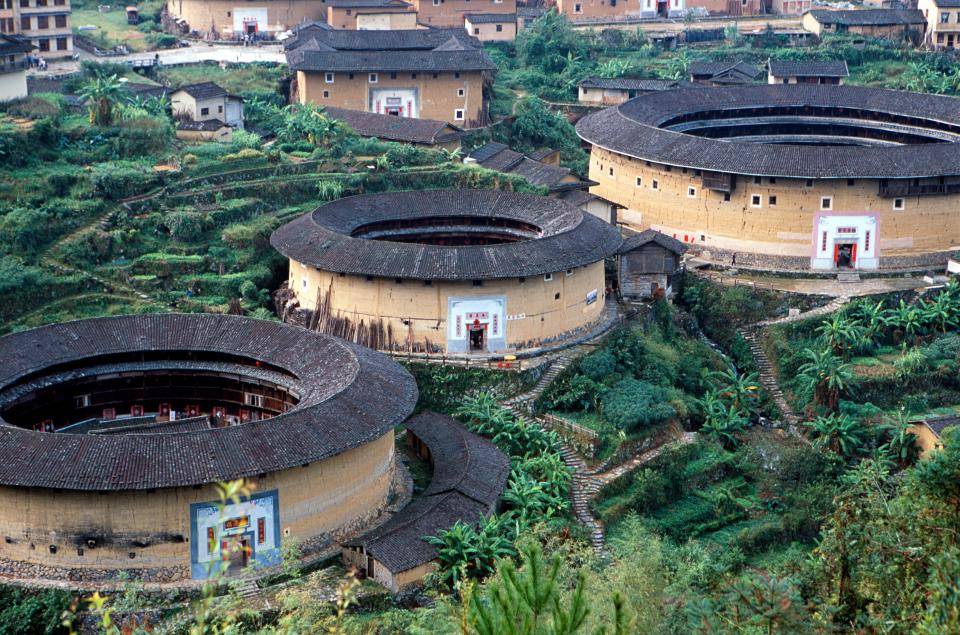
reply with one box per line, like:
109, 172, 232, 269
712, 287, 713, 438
190, 490, 280, 580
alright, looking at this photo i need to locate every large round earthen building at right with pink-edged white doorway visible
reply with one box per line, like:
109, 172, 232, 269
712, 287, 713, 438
577, 84, 960, 270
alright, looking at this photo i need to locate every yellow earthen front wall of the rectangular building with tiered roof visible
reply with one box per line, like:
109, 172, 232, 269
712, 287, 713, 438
297, 71, 484, 128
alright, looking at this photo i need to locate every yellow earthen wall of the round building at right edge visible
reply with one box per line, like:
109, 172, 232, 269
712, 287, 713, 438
589, 147, 960, 268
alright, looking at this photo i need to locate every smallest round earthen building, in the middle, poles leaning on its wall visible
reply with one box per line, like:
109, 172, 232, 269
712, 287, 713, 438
270, 190, 621, 353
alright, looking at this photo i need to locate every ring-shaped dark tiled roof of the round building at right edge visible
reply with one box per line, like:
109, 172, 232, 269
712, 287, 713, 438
577, 84, 960, 178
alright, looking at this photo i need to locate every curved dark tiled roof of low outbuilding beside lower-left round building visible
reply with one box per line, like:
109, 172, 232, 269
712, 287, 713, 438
346, 412, 510, 573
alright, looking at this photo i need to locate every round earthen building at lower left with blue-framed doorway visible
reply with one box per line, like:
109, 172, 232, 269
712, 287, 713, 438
0, 315, 417, 581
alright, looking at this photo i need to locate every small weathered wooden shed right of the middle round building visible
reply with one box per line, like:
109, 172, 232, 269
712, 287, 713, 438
617, 229, 687, 300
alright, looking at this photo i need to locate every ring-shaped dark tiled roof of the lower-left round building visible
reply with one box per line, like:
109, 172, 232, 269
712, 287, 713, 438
0, 314, 417, 491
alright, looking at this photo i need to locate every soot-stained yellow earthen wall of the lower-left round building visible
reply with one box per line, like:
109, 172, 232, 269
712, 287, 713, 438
0, 432, 394, 579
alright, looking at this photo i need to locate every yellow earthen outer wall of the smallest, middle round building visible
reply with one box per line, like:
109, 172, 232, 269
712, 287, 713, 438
289, 260, 604, 350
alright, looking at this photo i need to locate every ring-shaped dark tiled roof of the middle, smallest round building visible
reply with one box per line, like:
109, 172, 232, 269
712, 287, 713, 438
270, 190, 620, 280
